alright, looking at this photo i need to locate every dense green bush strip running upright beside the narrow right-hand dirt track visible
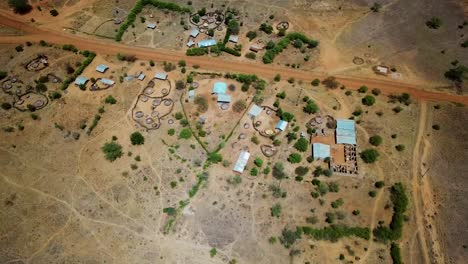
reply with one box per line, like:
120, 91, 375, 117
373, 182, 408, 242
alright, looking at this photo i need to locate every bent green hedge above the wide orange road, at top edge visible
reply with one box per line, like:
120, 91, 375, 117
115, 0, 191, 41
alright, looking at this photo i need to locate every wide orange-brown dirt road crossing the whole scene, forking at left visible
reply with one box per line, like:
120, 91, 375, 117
0, 10, 468, 104
